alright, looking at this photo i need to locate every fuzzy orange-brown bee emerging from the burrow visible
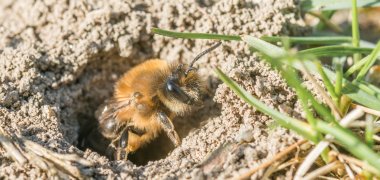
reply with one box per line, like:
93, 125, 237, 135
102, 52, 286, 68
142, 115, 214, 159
84, 42, 221, 160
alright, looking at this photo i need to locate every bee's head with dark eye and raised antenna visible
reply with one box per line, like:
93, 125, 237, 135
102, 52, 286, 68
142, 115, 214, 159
159, 42, 221, 112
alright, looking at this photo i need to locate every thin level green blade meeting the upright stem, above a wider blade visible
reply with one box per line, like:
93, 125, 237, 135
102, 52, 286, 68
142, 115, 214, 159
260, 36, 352, 45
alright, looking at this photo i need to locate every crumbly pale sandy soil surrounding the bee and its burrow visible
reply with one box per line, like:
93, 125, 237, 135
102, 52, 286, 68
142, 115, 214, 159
0, 0, 306, 179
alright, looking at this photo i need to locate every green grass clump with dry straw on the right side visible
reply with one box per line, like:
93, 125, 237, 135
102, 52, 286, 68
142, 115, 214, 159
152, 0, 380, 178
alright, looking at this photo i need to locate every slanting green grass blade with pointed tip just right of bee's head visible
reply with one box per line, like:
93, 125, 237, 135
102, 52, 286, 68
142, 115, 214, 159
215, 68, 317, 142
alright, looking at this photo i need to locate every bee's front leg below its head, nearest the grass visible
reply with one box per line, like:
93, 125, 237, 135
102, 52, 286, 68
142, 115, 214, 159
157, 112, 181, 146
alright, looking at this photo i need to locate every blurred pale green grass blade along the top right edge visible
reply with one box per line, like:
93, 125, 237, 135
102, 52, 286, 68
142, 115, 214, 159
301, 0, 380, 11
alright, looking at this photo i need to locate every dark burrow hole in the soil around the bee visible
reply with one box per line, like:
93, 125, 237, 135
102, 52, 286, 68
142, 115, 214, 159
70, 52, 220, 165
